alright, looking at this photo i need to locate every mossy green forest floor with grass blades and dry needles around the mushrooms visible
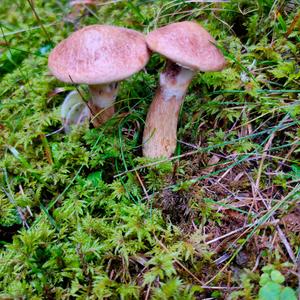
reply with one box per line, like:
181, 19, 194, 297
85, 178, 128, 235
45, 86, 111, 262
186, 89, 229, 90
0, 0, 300, 300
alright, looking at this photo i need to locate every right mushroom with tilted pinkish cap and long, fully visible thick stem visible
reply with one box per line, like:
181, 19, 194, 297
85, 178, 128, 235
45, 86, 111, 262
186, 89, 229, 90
143, 21, 225, 158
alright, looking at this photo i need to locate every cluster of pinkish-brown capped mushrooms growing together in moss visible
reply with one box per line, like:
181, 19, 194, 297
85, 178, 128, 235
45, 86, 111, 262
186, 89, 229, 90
48, 21, 225, 158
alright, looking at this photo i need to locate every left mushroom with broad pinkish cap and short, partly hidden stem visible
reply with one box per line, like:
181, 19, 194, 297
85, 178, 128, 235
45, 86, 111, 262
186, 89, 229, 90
48, 25, 149, 127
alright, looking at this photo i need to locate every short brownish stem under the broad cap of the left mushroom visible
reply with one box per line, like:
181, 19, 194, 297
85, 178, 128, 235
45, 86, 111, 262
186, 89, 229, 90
88, 82, 118, 127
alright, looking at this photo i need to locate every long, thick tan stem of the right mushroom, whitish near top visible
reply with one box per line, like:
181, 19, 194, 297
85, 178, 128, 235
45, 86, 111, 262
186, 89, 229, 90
143, 61, 195, 158
